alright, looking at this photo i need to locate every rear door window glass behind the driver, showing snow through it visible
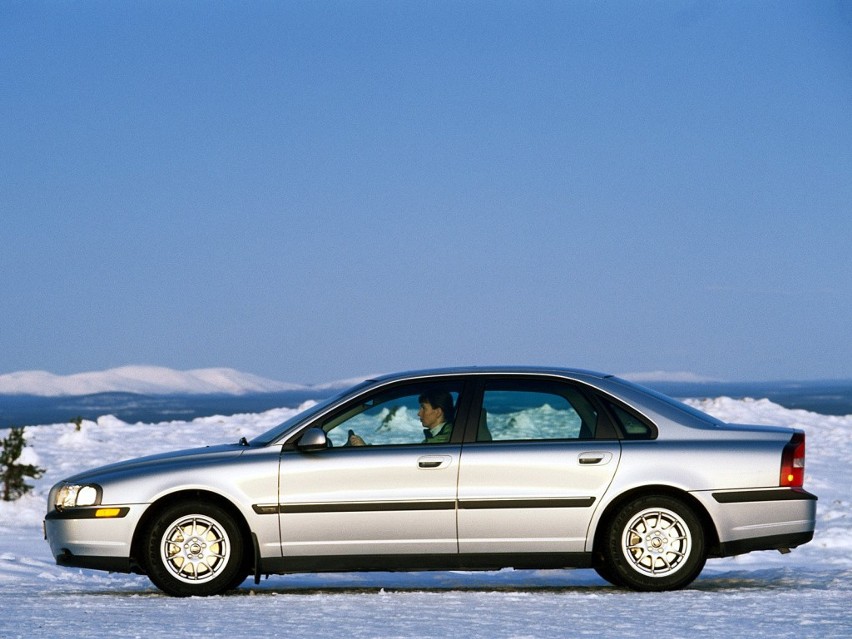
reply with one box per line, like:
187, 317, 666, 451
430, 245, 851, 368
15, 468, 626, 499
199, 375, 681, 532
476, 380, 598, 442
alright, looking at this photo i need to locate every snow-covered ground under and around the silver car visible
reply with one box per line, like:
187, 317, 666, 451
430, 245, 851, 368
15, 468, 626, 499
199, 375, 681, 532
0, 398, 852, 639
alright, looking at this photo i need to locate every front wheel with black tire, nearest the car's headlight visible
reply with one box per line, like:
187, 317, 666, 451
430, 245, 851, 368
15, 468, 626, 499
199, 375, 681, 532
145, 502, 246, 597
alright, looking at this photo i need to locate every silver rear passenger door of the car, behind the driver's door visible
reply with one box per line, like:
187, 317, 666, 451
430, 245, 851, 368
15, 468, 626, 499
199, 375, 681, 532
458, 378, 621, 554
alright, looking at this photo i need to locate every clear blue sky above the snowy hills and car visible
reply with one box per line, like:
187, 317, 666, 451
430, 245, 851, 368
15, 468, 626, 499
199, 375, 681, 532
0, 1, 852, 382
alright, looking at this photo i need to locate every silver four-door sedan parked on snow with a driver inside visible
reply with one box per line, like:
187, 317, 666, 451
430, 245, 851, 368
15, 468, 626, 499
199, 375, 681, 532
44, 367, 817, 596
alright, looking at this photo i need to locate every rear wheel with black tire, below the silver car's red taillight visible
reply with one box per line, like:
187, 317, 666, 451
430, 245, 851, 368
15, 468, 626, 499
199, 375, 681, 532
598, 495, 707, 591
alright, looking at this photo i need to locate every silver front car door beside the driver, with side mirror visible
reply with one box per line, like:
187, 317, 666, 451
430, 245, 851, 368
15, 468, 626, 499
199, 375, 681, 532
278, 382, 462, 557
